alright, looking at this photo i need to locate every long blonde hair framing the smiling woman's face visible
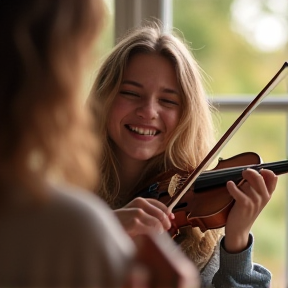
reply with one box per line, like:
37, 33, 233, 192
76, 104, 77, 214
89, 23, 214, 206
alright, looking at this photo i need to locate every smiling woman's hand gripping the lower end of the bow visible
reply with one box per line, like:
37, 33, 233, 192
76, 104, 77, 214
114, 197, 174, 237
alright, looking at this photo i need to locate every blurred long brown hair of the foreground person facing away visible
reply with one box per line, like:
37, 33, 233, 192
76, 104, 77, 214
0, 0, 104, 197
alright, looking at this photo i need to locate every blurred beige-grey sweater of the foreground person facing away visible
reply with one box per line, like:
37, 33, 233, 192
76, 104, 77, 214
0, 187, 134, 288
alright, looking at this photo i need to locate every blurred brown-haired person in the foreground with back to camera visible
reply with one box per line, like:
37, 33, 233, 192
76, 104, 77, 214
0, 0, 198, 287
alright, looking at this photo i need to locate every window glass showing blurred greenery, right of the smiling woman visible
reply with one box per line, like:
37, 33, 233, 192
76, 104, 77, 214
173, 0, 288, 288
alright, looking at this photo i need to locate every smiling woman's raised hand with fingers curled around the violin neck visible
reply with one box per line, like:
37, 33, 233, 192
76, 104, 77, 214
224, 169, 277, 253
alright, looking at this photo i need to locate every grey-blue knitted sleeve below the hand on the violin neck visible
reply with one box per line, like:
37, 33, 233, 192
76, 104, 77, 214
212, 234, 271, 288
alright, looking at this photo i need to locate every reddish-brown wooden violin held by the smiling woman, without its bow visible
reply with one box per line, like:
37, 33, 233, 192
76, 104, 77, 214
135, 152, 288, 237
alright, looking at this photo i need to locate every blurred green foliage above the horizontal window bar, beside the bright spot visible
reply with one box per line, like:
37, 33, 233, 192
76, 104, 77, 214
173, 0, 287, 94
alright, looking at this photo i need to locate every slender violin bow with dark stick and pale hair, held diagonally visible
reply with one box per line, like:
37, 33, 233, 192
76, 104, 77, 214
168, 61, 288, 211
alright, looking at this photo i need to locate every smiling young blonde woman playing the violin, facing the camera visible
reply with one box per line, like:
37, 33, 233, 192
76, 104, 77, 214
89, 25, 277, 288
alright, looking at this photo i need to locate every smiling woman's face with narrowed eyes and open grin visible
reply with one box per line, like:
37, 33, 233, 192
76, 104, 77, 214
108, 54, 181, 163
